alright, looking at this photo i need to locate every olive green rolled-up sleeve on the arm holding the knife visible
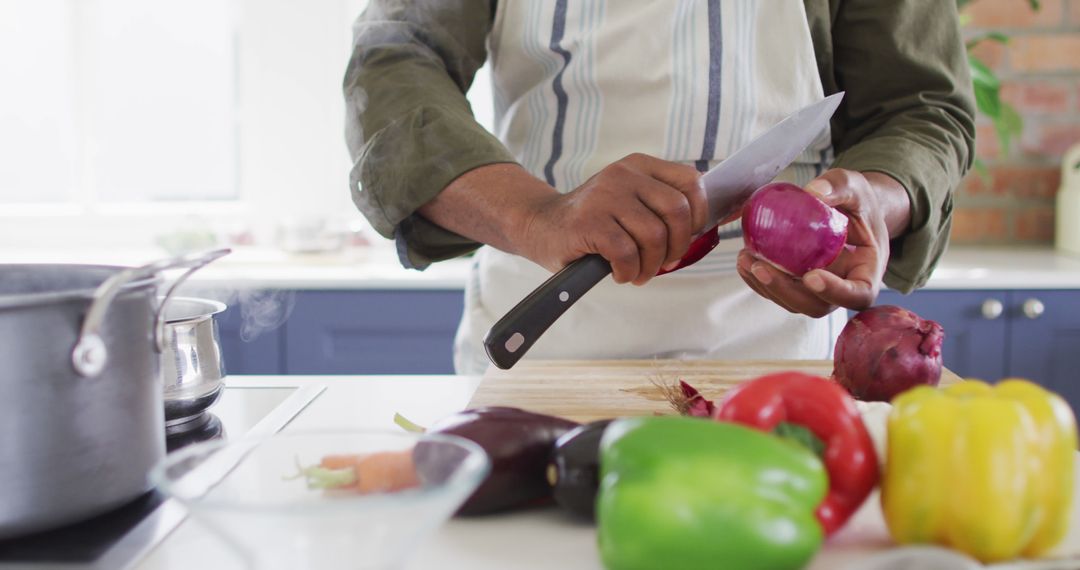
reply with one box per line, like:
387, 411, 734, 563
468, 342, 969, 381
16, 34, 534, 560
343, 0, 514, 269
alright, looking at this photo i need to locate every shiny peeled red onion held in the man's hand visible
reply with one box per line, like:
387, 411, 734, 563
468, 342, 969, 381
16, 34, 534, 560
742, 182, 848, 276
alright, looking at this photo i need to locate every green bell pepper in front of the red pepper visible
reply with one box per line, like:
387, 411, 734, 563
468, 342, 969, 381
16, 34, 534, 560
596, 417, 828, 570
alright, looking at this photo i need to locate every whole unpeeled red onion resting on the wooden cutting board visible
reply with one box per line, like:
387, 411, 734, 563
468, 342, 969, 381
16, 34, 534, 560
833, 304, 945, 402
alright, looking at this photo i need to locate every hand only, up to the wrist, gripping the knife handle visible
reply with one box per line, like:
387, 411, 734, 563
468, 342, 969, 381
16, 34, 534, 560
516, 154, 707, 285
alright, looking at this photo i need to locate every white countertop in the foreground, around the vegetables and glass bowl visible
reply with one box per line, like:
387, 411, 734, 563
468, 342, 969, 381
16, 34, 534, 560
136, 376, 1080, 570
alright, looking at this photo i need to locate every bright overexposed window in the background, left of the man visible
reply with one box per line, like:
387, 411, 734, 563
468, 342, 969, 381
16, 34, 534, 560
0, 0, 492, 247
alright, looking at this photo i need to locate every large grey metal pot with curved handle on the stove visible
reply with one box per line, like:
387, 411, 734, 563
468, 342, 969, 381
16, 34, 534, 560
0, 249, 228, 539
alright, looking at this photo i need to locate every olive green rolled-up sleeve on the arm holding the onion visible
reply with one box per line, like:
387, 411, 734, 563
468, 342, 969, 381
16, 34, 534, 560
832, 0, 974, 293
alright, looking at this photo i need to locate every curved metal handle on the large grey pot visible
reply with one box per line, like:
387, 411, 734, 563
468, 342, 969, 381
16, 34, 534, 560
71, 248, 231, 378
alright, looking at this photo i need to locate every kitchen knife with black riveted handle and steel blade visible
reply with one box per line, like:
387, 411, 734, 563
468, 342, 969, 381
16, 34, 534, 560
484, 92, 843, 369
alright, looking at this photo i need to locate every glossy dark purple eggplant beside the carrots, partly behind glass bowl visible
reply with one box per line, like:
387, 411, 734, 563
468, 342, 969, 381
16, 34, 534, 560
414, 407, 579, 516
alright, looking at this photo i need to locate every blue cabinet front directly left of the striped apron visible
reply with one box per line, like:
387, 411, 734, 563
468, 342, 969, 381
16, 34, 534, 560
285, 289, 464, 375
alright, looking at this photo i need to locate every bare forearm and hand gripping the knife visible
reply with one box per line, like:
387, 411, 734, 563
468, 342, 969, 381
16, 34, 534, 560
420, 154, 707, 285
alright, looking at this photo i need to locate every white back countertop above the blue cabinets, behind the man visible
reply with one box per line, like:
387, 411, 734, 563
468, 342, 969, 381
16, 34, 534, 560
0, 246, 1080, 289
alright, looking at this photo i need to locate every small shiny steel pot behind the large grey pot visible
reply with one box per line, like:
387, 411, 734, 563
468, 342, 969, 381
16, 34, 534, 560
161, 297, 226, 433
